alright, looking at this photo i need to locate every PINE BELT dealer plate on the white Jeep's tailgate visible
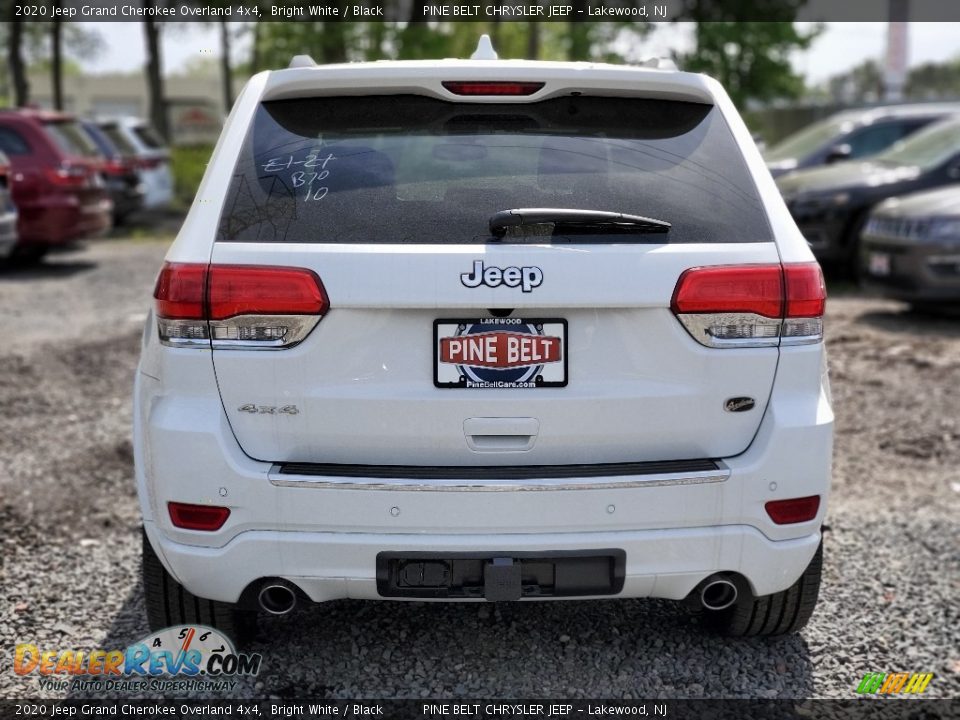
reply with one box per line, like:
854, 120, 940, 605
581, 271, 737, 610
433, 317, 567, 390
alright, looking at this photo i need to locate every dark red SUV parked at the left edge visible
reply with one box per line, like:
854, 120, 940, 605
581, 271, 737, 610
0, 109, 113, 258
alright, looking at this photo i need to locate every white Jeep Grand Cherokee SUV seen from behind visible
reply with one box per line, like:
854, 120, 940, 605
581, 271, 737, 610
134, 42, 833, 639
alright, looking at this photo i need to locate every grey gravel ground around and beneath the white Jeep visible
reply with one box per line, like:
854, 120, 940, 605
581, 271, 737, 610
0, 241, 960, 698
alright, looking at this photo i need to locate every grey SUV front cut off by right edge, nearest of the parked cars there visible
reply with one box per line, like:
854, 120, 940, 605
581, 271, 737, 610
860, 185, 960, 307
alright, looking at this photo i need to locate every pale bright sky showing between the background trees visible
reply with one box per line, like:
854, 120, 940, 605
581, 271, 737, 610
83, 22, 960, 85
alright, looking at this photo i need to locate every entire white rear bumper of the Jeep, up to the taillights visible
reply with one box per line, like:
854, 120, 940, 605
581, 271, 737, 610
134, 340, 833, 602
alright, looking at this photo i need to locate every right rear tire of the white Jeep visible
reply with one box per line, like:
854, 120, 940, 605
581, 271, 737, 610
703, 541, 823, 637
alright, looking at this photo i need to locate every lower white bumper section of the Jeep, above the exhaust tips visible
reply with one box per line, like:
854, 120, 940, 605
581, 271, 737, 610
145, 523, 820, 602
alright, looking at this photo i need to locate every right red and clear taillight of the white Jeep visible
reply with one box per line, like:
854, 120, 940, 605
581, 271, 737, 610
671, 263, 827, 347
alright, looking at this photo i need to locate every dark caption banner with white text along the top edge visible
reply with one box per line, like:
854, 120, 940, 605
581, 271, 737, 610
11, 0, 960, 23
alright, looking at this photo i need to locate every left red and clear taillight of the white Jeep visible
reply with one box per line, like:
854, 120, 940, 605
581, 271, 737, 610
153, 263, 329, 349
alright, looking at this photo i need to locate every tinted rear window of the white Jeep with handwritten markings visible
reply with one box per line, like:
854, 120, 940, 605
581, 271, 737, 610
217, 95, 772, 244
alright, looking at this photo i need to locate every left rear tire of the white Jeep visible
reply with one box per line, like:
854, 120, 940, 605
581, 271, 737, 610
142, 532, 257, 648
